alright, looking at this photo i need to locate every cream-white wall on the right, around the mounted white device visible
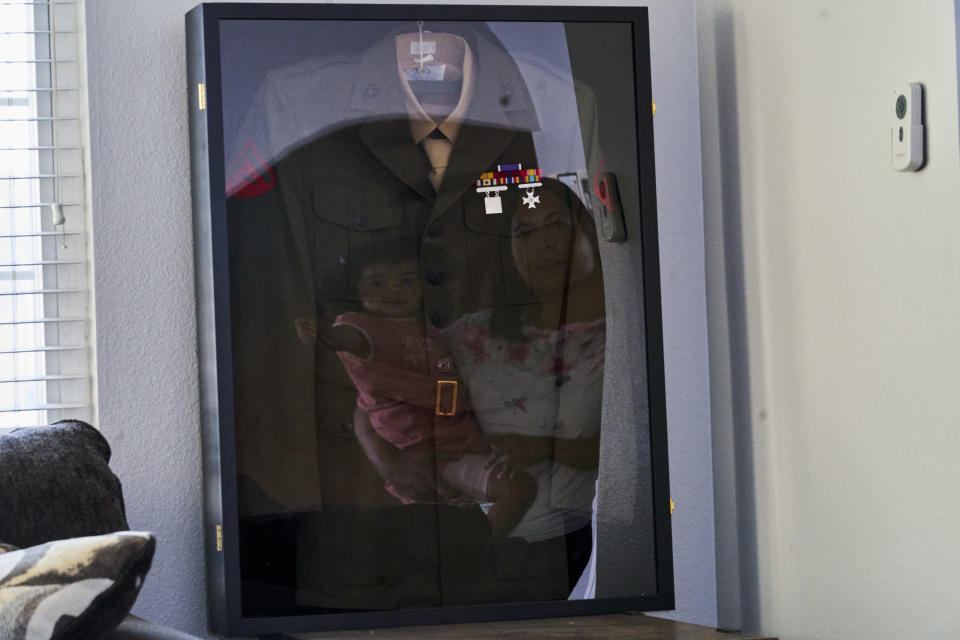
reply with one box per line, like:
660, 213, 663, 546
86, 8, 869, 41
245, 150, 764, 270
698, 0, 960, 640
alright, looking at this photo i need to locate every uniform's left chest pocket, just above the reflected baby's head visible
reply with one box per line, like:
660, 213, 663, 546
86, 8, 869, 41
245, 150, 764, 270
311, 181, 412, 301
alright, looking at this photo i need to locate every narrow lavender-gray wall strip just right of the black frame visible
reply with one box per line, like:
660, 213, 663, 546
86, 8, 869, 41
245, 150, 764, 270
638, 0, 716, 626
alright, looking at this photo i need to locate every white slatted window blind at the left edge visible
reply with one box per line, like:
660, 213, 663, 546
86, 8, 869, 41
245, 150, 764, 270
0, 0, 92, 428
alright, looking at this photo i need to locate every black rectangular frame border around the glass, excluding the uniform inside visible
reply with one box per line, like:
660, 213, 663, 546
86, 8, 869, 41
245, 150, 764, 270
186, 3, 674, 635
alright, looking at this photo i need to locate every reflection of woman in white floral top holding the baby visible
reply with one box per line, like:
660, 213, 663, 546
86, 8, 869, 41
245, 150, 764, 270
447, 181, 605, 588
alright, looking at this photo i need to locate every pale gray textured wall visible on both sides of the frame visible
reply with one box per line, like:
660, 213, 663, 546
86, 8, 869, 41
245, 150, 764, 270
86, 0, 716, 633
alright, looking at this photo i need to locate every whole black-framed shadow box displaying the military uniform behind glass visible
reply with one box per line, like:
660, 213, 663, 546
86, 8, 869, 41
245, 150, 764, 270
186, 4, 673, 635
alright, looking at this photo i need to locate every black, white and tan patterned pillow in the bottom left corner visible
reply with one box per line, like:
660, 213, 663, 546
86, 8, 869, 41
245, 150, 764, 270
0, 531, 155, 640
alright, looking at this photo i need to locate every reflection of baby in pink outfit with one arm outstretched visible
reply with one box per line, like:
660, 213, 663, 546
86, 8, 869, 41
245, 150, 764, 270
297, 239, 537, 536
